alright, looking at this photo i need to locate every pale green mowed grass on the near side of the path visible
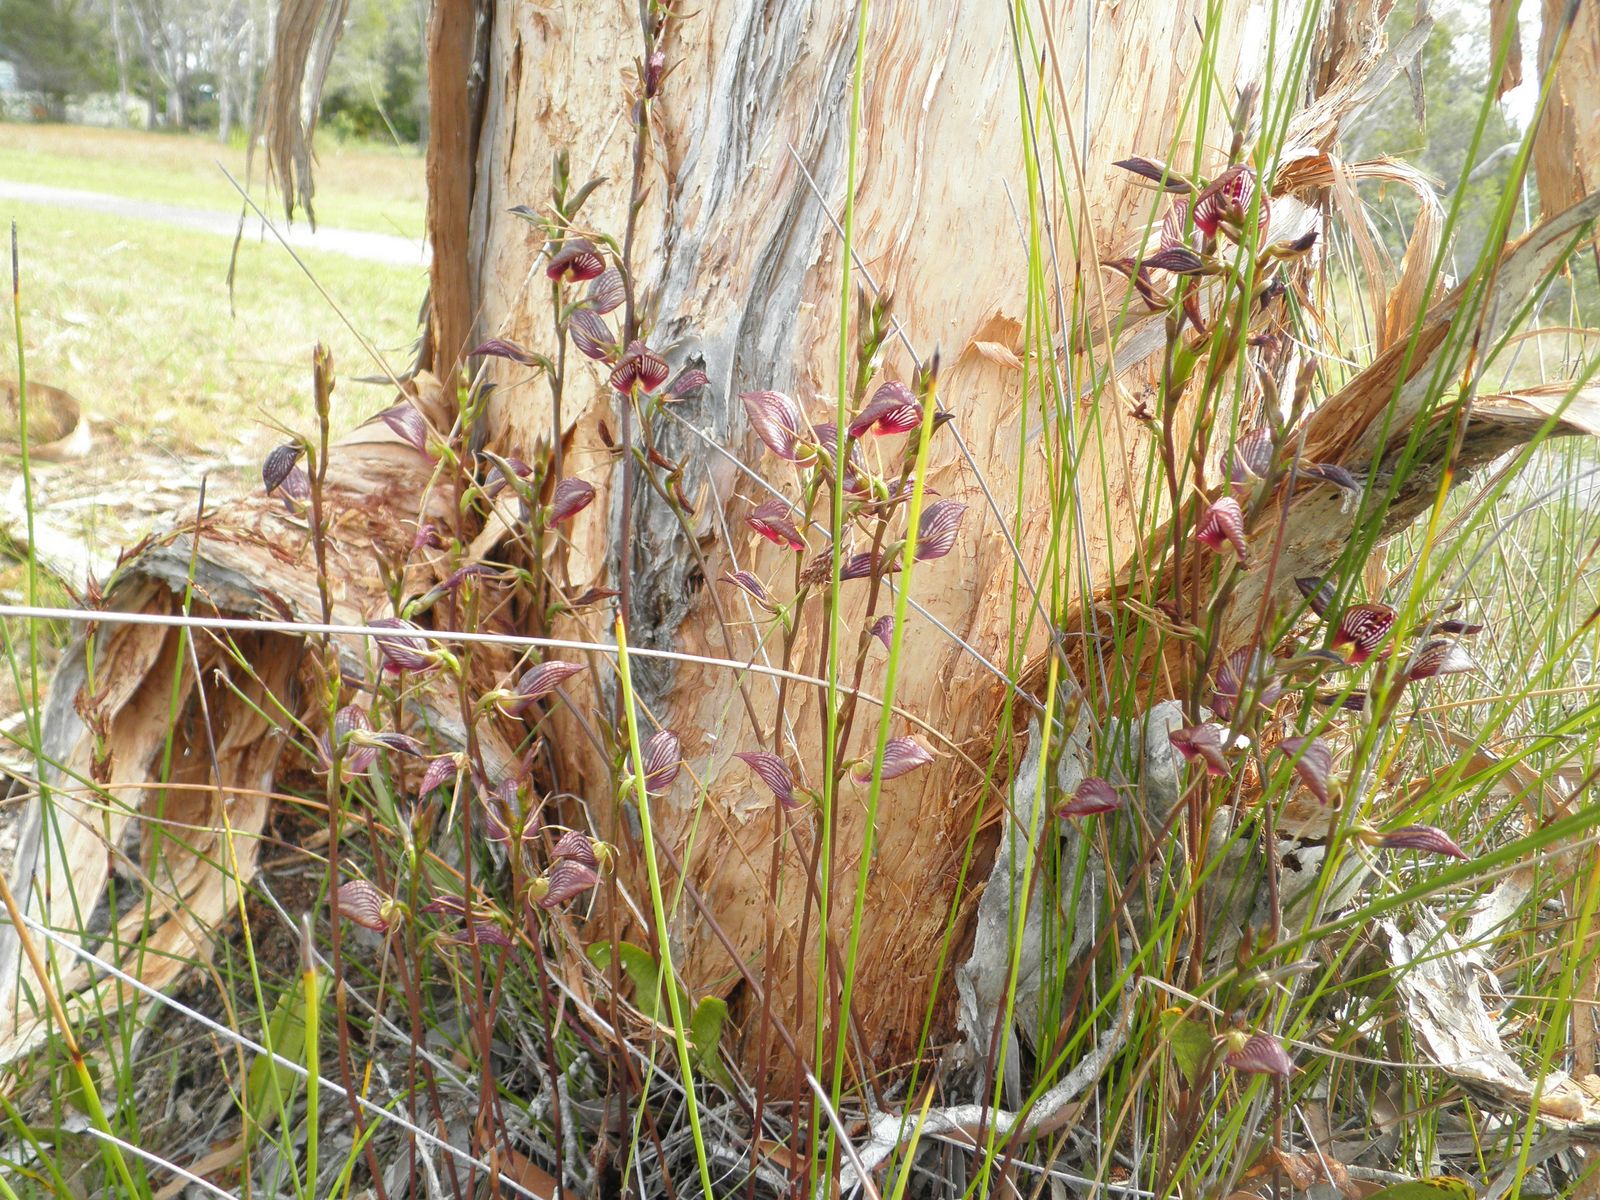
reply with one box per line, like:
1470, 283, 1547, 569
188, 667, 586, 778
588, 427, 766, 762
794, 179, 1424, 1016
11, 205, 426, 456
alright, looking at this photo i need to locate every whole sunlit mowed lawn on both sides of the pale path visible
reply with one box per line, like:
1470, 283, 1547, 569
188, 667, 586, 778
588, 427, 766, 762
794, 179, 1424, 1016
0, 126, 427, 457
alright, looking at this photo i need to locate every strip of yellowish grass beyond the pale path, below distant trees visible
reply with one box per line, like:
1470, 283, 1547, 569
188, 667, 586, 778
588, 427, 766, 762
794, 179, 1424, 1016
0, 123, 427, 238
